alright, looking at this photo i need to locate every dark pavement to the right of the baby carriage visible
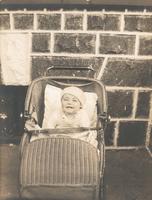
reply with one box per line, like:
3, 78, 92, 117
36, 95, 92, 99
105, 149, 152, 200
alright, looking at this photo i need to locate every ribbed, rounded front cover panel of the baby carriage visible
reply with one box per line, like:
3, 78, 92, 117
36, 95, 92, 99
20, 137, 99, 188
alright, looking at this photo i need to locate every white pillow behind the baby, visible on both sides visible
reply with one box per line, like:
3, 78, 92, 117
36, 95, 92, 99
42, 84, 97, 128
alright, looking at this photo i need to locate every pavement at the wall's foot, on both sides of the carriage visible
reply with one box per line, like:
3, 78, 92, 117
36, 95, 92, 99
0, 144, 152, 200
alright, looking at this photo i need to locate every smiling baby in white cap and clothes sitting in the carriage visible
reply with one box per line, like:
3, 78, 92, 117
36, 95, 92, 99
42, 87, 90, 128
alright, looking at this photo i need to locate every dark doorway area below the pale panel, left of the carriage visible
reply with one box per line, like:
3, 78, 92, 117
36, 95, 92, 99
0, 86, 27, 144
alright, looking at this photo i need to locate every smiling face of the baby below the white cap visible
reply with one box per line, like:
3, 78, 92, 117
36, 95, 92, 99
61, 94, 81, 114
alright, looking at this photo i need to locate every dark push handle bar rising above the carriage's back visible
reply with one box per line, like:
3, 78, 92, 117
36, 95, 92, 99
45, 65, 96, 77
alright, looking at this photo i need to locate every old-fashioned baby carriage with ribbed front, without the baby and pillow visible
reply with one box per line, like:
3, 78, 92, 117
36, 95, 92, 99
19, 69, 107, 200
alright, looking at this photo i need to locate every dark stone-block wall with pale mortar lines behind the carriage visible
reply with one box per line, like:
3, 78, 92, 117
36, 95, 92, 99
0, 9, 152, 148
